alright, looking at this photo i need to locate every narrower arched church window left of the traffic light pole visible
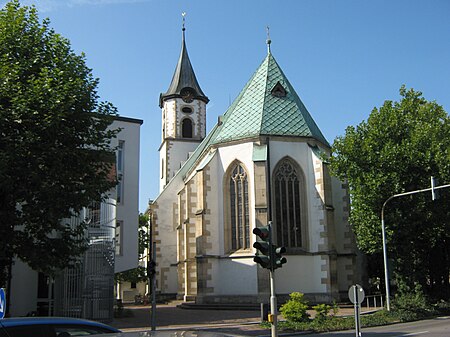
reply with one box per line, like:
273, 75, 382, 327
229, 164, 250, 250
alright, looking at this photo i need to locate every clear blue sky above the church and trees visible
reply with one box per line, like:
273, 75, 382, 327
0, 0, 450, 211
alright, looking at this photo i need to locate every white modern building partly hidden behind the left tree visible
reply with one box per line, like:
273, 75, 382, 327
10, 117, 142, 321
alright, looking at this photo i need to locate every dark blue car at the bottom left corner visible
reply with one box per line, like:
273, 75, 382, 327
0, 317, 120, 337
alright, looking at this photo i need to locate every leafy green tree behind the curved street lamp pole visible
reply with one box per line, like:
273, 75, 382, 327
330, 86, 450, 296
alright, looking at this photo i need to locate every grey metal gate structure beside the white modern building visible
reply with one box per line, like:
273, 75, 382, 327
54, 199, 116, 322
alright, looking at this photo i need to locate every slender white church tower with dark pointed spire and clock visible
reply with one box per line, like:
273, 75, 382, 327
159, 19, 209, 192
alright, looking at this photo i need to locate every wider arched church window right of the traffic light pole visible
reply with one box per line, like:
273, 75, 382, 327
273, 158, 305, 248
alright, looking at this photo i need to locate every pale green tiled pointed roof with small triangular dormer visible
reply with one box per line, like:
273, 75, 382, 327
212, 53, 329, 146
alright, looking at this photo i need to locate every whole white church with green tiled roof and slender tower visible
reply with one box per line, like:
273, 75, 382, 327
149, 27, 361, 304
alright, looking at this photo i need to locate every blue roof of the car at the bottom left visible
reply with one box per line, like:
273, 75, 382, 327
0, 317, 120, 332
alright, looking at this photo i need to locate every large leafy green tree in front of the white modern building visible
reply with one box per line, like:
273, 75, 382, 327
0, 0, 118, 286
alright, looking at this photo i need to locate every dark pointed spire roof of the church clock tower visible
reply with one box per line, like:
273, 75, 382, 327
159, 26, 209, 107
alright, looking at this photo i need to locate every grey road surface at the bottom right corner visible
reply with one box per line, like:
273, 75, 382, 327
306, 317, 450, 337
